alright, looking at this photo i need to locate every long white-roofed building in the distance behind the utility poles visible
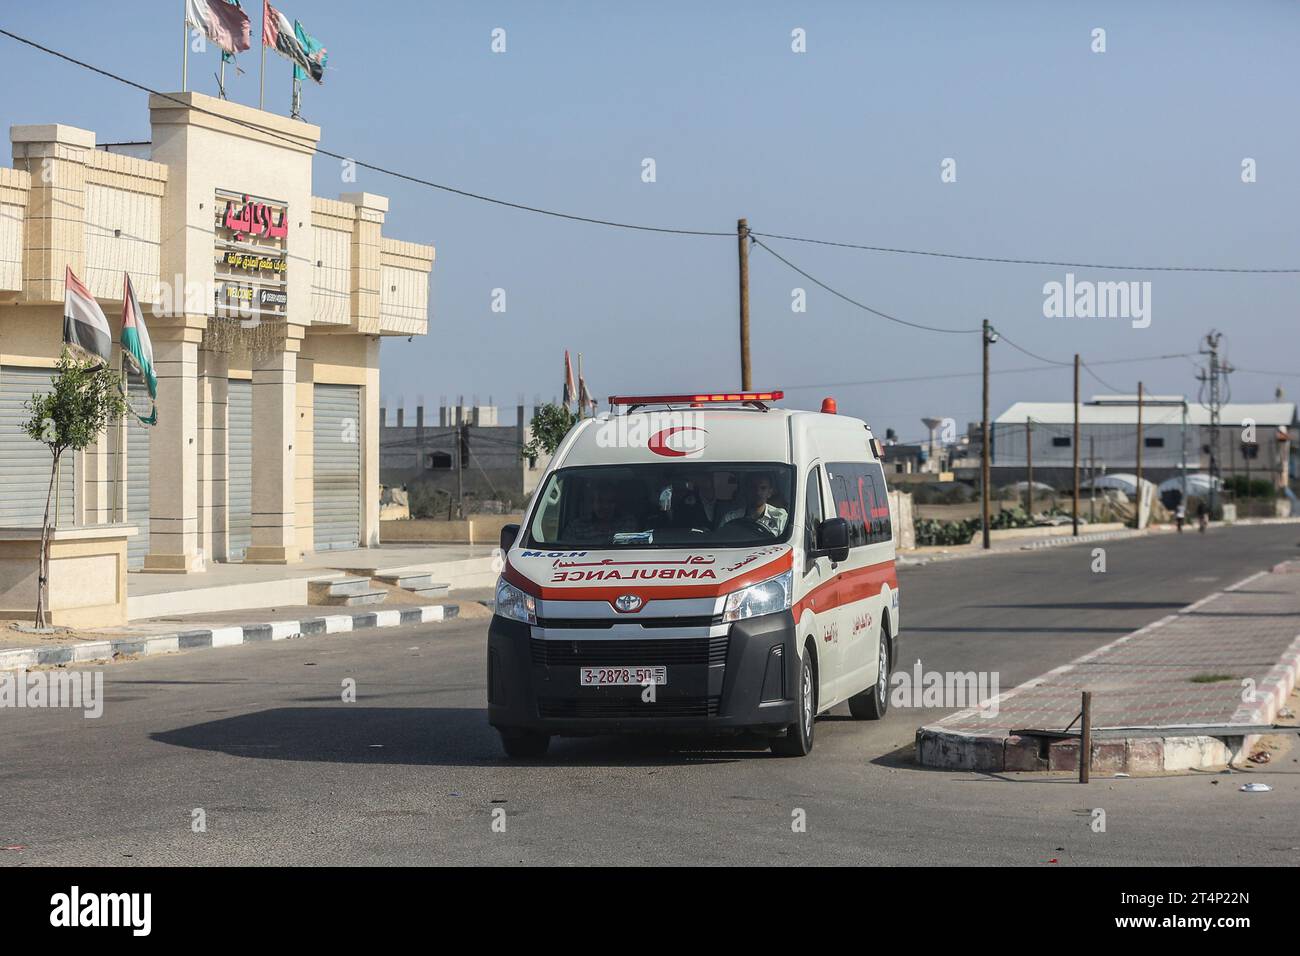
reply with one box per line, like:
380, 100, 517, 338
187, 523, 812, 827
991, 394, 1300, 488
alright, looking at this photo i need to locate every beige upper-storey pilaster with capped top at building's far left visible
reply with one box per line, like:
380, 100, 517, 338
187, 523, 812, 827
9, 125, 92, 303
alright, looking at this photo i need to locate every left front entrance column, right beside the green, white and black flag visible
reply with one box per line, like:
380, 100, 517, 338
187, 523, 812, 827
144, 320, 204, 574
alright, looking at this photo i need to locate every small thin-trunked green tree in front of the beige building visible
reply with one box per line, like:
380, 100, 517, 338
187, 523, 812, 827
21, 349, 126, 628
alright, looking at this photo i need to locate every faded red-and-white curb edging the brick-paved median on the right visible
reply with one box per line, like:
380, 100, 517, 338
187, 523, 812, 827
917, 562, 1300, 774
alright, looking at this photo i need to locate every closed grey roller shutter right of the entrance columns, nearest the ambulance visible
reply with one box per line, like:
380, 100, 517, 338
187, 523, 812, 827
312, 385, 361, 551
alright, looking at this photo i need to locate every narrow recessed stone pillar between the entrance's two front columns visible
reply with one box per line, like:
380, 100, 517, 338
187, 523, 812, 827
199, 349, 230, 561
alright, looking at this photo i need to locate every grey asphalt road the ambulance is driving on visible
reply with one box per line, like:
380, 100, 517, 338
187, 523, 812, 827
0, 525, 1300, 865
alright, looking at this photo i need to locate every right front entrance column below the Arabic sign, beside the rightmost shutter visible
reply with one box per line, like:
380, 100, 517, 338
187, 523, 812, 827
244, 337, 302, 564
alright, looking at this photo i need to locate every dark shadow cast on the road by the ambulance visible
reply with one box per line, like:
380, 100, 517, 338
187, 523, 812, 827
150, 705, 771, 766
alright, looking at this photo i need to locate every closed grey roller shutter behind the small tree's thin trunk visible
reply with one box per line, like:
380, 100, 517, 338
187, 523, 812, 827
0, 365, 77, 528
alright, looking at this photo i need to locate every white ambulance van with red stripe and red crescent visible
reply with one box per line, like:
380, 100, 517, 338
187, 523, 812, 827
488, 392, 900, 757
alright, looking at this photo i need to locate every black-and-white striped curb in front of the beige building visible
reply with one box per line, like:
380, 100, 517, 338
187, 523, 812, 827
0, 604, 460, 671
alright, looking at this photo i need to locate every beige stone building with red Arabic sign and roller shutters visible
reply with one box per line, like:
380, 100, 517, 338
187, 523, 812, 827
0, 92, 434, 582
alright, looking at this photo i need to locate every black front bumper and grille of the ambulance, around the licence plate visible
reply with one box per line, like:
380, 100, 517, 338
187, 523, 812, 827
488, 611, 798, 736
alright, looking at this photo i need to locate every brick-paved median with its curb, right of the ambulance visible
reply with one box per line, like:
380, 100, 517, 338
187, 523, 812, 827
917, 562, 1300, 771
